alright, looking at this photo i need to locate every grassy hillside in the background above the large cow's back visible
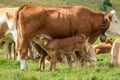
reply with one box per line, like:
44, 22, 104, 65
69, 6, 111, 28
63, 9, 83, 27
0, 0, 120, 18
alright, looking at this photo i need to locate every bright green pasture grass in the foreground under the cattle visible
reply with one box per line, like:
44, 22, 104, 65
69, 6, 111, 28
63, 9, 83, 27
0, 37, 120, 80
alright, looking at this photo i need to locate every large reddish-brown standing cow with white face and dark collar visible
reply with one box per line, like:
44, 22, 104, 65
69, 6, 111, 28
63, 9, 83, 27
16, 5, 117, 70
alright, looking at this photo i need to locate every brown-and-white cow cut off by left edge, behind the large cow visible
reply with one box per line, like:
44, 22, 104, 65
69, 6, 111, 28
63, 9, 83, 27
0, 8, 18, 59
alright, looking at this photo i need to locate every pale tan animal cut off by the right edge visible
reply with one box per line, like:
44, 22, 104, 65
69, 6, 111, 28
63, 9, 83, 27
111, 39, 120, 66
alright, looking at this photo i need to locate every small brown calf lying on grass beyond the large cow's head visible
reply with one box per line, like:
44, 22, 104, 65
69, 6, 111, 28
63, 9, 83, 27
93, 38, 112, 54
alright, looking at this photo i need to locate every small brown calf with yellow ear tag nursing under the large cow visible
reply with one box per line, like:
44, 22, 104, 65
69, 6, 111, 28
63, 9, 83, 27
34, 35, 94, 71
